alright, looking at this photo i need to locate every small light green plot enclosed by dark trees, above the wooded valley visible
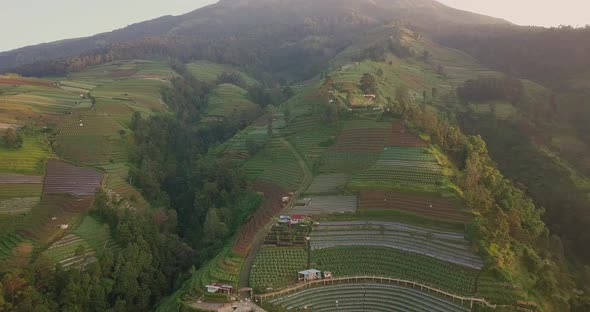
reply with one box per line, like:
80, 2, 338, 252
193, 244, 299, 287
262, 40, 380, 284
207, 83, 258, 120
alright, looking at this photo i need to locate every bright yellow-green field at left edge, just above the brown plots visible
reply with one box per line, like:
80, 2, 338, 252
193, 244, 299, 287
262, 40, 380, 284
0, 136, 51, 174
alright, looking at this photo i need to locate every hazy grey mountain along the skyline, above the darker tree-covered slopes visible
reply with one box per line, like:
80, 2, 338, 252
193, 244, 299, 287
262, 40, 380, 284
0, 0, 509, 69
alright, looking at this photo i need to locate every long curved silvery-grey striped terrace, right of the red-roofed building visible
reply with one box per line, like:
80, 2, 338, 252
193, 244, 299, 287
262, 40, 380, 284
311, 221, 483, 270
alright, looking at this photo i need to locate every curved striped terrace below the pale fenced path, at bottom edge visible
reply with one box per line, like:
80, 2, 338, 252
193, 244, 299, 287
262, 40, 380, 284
270, 283, 471, 312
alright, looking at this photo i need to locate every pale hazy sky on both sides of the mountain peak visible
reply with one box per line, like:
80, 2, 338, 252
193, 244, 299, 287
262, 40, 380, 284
0, 0, 590, 51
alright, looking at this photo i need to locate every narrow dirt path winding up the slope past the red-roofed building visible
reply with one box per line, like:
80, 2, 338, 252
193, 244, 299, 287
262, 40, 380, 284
239, 138, 313, 288
